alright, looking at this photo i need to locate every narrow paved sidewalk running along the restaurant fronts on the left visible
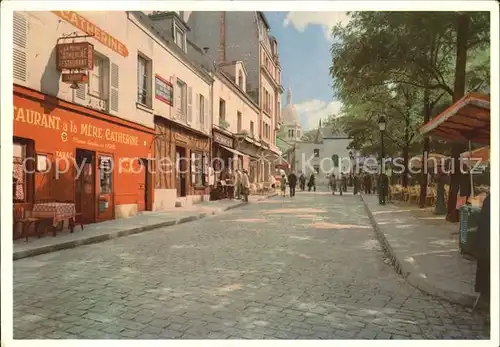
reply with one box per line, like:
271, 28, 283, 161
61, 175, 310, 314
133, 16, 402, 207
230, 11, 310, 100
13, 194, 276, 260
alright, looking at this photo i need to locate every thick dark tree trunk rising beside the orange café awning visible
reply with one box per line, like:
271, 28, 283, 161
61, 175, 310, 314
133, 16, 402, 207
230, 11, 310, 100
446, 13, 470, 222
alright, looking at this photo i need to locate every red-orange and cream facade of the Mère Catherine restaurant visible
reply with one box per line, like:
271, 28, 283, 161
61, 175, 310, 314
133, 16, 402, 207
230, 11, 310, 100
13, 11, 155, 223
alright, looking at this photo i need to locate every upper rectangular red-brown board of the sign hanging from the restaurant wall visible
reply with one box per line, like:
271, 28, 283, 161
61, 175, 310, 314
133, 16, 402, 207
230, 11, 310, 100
56, 42, 94, 71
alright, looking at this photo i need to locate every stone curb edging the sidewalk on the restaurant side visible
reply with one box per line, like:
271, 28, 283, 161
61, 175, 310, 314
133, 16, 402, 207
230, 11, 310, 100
12, 195, 276, 261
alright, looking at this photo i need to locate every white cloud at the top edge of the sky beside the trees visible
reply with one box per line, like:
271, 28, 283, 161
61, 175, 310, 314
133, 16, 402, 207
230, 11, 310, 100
283, 12, 350, 40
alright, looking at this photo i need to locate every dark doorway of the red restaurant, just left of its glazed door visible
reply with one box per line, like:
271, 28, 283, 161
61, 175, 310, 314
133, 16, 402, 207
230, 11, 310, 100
75, 148, 96, 224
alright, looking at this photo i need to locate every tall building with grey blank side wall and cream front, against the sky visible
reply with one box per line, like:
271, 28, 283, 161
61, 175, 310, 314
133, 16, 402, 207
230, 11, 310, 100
187, 11, 283, 182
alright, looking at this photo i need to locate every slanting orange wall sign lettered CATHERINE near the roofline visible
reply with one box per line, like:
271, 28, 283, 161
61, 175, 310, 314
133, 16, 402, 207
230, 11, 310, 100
52, 11, 128, 57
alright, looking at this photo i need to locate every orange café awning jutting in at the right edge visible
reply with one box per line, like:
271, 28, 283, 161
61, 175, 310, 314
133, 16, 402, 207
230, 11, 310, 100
420, 92, 490, 144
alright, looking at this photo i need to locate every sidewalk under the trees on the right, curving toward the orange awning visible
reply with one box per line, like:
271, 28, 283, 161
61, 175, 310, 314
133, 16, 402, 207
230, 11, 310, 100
361, 195, 476, 307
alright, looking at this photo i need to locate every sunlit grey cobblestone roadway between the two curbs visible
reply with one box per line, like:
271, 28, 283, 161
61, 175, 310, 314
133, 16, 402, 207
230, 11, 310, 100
14, 192, 489, 339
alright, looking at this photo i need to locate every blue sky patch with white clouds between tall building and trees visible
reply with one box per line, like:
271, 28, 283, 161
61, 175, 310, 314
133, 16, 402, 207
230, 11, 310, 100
266, 12, 348, 130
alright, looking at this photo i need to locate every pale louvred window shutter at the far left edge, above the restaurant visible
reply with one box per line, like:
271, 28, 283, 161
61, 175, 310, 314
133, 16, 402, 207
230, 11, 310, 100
12, 12, 28, 82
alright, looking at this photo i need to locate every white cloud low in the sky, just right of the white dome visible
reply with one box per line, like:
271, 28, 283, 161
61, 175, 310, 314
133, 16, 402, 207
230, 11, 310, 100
295, 99, 342, 131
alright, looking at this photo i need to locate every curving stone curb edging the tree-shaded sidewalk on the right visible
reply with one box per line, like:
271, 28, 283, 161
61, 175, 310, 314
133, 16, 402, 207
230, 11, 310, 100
360, 195, 477, 308
